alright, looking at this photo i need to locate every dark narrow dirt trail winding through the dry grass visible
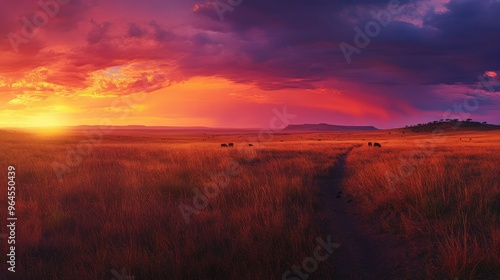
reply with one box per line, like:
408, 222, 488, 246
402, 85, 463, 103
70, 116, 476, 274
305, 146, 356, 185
317, 145, 425, 280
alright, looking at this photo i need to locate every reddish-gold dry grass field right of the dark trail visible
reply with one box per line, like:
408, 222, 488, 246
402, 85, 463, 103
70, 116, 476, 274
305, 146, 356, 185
345, 131, 500, 279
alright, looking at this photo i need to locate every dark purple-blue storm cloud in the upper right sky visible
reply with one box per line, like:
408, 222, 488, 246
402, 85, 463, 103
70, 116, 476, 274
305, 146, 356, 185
193, 0, 500, 85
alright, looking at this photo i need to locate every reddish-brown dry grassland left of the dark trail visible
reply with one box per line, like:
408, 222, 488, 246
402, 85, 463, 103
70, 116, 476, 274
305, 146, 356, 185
0, 128, 352, 280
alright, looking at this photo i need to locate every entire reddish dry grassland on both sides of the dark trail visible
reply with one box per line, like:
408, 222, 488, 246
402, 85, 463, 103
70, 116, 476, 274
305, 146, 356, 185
0, 130, 500, 280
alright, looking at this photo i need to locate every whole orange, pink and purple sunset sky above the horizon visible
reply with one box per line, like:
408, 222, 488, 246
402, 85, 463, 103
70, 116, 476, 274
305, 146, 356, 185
0, 0, 500, 128
